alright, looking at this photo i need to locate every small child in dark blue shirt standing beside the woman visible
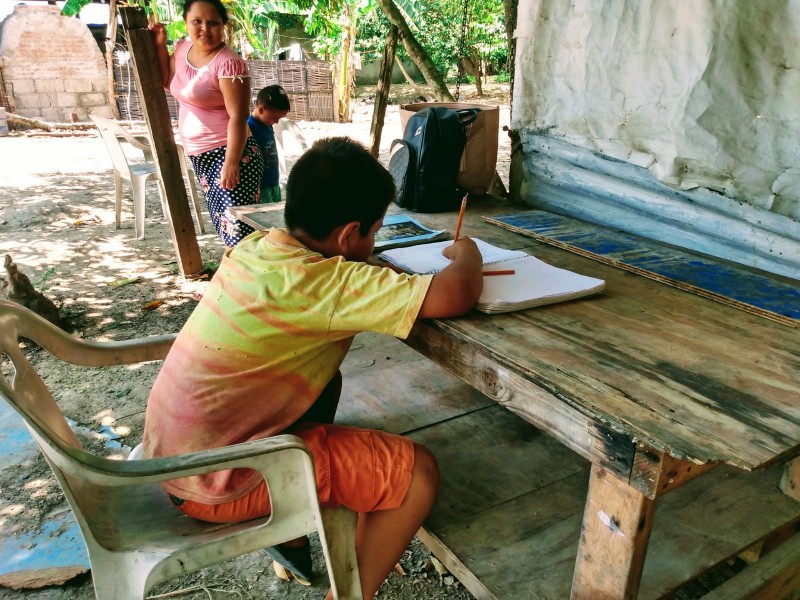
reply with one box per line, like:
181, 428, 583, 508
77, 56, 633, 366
247, 85, 291, 203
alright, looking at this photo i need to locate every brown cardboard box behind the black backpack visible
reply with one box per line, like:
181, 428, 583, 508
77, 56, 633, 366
400, 102, 500, 194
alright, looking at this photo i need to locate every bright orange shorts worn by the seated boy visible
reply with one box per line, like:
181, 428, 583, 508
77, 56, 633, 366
173, 423, 414, 523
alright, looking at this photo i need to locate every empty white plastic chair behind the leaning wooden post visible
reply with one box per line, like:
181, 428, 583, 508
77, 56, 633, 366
90, 115, 205, 240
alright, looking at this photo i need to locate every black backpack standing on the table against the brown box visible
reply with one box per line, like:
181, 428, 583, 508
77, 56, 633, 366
389, 106, 478, 212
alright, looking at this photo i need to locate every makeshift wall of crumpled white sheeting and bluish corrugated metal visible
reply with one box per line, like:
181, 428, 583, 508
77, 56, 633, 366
511, 0, 800, 277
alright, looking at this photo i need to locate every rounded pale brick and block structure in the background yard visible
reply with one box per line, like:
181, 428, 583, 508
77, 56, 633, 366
0, 5, 111, 122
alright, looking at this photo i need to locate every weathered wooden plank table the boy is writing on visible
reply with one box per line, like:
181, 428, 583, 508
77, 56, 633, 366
398, 196, 800, 600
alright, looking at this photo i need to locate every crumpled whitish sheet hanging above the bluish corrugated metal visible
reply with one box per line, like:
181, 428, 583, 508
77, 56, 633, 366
511, 0, 800, 276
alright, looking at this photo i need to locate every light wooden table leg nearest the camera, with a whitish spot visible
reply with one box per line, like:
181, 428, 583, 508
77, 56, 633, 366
571, 464, 655, 600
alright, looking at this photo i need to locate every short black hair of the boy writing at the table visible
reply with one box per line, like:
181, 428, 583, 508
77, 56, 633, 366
283, 137, 394, 240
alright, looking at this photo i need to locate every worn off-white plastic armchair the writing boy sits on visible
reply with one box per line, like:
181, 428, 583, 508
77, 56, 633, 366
0, 300, 361, 600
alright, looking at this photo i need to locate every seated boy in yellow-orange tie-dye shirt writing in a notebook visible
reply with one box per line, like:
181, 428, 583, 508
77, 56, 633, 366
144, 138, 483, 598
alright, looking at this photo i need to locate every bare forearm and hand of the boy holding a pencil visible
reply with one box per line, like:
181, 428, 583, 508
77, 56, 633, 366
417, 237, 483, 319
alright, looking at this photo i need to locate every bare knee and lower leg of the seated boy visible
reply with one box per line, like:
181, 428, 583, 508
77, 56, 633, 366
326, 443, 439, 600
